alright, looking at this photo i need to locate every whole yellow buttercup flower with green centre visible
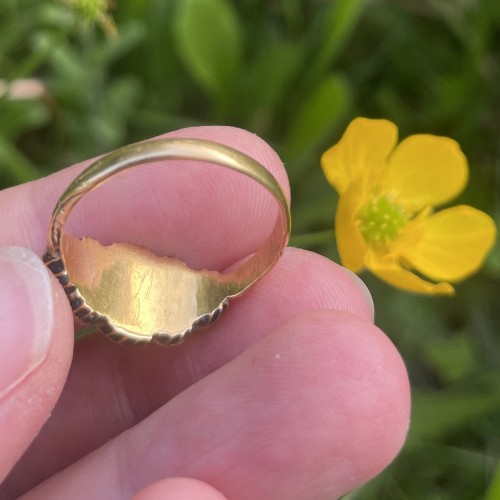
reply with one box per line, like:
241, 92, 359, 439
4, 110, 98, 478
321, 118, 496, 294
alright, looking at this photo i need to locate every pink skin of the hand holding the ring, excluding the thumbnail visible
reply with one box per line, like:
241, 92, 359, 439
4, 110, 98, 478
0, 127, 409, 499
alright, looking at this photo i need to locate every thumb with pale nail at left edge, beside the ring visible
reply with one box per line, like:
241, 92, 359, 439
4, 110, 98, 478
0, 247, 73, 481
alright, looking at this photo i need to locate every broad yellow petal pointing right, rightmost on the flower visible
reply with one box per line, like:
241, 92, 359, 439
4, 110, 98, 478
404, 205, 496, 282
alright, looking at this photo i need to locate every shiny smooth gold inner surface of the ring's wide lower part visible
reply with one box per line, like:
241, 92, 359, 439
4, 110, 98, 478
61, 209, 283, 339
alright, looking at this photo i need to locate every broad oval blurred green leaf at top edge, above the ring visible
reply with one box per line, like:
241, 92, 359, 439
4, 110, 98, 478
173, 0, 243, 97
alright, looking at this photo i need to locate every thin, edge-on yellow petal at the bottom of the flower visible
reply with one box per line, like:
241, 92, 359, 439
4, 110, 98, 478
365, 252, 454, 295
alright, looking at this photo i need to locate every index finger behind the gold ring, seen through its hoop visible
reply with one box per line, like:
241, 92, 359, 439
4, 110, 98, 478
0, 127, 289, 270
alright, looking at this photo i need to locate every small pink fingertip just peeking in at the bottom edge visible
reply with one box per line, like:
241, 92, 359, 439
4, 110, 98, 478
133, 477, 226, 500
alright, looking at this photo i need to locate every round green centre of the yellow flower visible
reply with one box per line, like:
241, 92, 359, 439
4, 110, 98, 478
358, 196, 409, 244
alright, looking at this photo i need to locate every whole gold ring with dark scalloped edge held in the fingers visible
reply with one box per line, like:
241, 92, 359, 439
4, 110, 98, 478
43, 139, 291, 344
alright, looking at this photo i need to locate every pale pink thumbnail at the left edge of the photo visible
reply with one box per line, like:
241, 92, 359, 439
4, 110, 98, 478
0, 247, 54, 398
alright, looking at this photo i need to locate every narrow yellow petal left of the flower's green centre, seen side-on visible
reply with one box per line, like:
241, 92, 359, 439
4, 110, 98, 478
335, 184, 366, 273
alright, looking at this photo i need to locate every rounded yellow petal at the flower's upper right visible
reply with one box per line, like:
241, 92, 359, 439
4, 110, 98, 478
380, 135, 468, 211
